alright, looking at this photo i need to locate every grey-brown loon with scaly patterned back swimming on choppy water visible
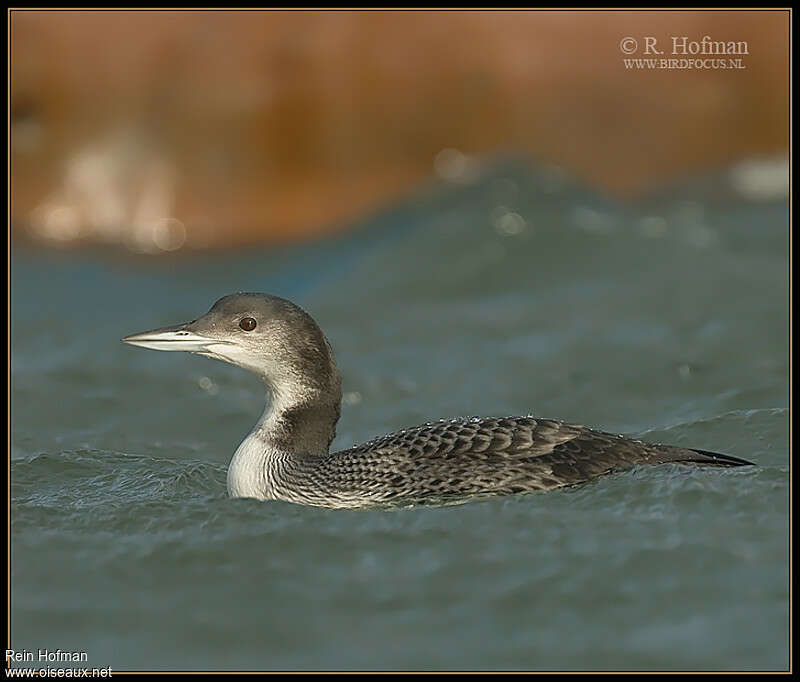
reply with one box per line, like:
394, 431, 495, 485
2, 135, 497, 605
122, 293, 751, 508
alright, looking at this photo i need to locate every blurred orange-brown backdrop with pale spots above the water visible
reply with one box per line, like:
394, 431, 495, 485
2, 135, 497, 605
10, 11, 789, 252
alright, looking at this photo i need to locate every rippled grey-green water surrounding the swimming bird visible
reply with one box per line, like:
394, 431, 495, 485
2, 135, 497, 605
11, 164, 789, 670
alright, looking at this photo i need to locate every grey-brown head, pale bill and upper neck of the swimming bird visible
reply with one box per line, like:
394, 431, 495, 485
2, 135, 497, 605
122, 293, 341, 432
